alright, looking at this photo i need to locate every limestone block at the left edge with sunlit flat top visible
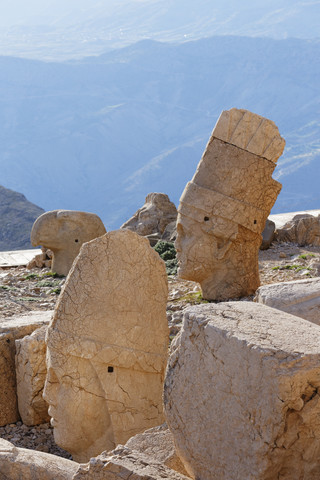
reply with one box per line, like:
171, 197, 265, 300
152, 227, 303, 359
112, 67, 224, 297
0, 311, 52, 426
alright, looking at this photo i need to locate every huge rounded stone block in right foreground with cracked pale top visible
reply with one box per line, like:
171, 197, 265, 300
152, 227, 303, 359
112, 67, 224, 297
164, 302, 320, 480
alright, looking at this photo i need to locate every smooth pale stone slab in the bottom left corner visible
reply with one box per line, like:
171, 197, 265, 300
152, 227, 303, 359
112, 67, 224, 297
0, 439, 79, 480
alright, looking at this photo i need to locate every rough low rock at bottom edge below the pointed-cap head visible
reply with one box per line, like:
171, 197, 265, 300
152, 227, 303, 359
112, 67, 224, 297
73, 445, 190, 480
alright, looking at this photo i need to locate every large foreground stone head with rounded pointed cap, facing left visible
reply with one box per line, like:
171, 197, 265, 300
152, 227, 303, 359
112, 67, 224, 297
44, 230, 168, 461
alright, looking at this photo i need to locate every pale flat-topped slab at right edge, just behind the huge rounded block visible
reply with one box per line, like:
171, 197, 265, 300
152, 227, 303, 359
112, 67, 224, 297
255, 278, 320, 325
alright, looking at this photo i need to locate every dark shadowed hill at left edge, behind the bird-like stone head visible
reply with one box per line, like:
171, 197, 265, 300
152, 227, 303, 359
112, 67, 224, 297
0, 185, 44, 251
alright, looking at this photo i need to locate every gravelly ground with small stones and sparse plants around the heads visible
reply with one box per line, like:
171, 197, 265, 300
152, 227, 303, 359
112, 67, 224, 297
0, 242, 320, 458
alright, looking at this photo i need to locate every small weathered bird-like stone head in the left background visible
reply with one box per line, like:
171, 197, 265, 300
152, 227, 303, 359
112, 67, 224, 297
31, 210, 106, 275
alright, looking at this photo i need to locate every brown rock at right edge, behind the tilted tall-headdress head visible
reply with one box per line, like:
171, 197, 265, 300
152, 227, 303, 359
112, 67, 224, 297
277, 213, 320, 247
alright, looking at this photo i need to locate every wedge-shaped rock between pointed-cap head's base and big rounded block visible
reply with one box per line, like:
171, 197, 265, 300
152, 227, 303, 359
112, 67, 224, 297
125, 423, 188, 476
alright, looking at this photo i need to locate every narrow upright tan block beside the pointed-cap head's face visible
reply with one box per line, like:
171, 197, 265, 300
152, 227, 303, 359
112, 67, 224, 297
16, 326, 50, 425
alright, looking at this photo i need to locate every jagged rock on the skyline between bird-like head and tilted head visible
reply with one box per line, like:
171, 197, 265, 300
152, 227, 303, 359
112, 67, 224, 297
120, 193, 177, 238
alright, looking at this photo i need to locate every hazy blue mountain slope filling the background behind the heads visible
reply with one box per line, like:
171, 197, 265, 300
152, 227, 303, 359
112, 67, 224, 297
0, 37, 320, 230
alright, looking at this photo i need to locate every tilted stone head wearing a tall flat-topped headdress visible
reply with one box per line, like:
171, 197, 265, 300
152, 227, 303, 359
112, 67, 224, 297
176, 108, 285, 300
